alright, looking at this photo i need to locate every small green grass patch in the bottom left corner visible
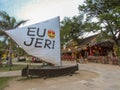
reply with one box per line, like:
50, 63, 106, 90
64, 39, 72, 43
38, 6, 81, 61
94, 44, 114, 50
0, 77, 13, 90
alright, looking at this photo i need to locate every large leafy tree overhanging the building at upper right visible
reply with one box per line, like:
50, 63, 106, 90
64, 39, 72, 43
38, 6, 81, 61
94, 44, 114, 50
79, 0, 120, 56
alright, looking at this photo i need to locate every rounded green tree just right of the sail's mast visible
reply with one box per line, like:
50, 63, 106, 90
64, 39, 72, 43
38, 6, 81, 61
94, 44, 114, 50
61, 15, 84, 45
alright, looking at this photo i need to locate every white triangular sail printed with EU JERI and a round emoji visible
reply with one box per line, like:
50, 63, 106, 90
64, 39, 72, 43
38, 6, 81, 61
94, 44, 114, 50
6, 17, 61, 66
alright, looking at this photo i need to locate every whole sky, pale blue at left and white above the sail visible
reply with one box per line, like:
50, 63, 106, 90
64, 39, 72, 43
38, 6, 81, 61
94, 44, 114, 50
0, 0, 84, 25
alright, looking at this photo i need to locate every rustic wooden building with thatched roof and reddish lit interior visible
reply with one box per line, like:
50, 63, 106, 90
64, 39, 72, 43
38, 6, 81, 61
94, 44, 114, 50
62, 34, 114, 63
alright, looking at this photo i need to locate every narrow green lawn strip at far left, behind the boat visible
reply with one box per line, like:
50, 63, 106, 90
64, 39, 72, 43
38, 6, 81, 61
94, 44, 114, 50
0, 65, 26, 72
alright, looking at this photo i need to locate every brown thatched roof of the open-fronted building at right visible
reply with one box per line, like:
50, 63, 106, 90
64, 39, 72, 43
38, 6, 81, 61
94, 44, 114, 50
62, 34, 114, 52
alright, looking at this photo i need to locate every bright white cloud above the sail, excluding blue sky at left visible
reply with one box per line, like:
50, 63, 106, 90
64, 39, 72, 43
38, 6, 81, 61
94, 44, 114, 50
17, 0, 82, 24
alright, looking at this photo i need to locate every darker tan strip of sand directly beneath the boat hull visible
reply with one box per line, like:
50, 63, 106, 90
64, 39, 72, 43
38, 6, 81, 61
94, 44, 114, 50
5, 70, 99, 90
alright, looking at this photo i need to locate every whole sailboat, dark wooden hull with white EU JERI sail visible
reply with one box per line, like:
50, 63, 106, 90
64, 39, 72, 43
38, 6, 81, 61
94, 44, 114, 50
6, 17, 78, 77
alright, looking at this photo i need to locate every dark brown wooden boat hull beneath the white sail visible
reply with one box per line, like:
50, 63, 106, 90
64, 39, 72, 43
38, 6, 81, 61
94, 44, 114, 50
22, 65, 78, 78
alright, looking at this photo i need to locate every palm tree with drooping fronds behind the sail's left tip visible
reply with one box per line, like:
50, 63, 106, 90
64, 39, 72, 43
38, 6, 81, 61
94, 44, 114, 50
0, 11, 27, 66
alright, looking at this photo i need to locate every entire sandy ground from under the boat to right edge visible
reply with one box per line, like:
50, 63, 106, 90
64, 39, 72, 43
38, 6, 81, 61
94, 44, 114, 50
5, 63, 120, 90
